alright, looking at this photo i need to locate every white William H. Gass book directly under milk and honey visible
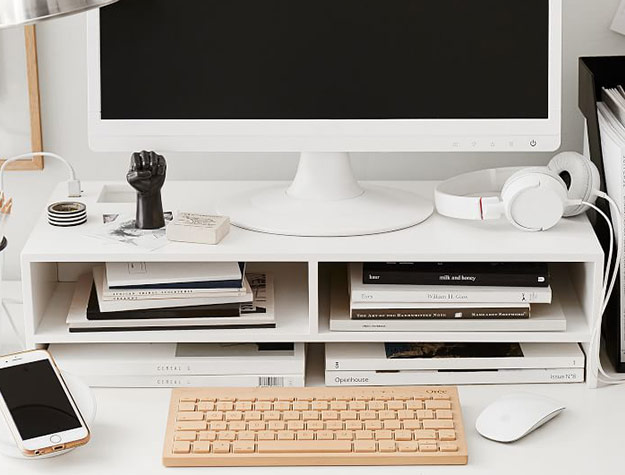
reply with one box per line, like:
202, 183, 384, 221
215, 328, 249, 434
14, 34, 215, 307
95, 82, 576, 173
349, 264, 552, 305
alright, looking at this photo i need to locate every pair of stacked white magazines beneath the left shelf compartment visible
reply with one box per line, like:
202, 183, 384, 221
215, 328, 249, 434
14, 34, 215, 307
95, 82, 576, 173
49, 343, 306, 387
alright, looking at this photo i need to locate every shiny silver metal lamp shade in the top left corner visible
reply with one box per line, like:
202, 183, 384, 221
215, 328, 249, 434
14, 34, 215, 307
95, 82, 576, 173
0, 0, 117, 28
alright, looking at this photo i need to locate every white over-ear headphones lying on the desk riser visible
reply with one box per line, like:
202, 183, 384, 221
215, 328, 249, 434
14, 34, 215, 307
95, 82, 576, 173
434, 152, 600, 231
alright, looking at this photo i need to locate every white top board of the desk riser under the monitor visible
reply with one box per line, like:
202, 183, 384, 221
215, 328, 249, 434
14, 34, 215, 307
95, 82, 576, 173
23, 181, 602, 262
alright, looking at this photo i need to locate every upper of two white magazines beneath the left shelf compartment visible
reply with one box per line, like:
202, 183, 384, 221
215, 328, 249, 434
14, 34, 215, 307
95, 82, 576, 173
48, 343, 306, 376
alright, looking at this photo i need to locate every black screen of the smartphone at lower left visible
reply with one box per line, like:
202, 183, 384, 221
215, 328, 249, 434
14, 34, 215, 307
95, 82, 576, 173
0, 360, 81, 440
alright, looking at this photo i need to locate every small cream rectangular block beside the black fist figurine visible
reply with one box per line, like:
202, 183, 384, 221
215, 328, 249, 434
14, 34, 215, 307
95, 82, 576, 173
167, 211, 230, 244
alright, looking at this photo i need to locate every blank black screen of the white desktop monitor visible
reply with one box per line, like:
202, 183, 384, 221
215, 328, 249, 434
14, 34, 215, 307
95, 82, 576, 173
100, 0, 549, 119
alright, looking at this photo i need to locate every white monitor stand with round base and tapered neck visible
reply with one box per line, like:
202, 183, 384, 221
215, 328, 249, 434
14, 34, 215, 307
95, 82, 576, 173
219, 152, 434, 237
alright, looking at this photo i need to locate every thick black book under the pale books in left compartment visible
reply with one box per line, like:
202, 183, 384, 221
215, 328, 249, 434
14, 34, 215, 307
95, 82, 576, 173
87, 285, 242, 320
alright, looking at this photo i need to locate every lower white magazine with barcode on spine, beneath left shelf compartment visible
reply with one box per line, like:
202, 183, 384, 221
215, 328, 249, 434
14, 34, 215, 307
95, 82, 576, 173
71, 372, 306, 388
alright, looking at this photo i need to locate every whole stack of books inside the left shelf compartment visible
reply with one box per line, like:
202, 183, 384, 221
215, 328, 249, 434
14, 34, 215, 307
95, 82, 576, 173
66, 262, 276, 332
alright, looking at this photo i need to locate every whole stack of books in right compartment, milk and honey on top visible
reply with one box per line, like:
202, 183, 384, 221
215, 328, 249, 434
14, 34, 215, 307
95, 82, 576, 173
330, 263, 566, 331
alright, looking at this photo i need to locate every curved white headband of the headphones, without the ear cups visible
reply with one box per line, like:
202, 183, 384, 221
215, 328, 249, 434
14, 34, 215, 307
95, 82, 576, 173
434, 167, 524, 221
